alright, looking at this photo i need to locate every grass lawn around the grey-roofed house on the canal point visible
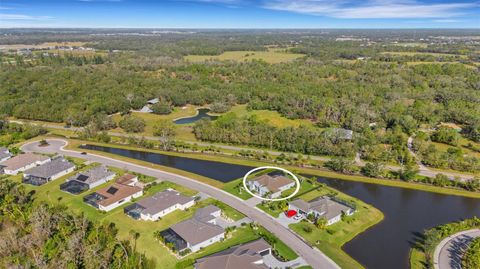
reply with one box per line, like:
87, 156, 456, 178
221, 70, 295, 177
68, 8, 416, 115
289, 187, 383, 269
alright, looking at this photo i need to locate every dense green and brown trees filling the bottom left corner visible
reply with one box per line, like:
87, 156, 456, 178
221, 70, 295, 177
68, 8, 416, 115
0, 179, 155, 269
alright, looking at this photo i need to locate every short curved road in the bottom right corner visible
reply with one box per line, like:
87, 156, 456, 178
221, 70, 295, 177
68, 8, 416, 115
433, 229, 480, 269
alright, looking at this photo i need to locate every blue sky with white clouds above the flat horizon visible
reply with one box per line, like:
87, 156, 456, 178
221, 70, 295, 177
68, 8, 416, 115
0, 0, 480, 29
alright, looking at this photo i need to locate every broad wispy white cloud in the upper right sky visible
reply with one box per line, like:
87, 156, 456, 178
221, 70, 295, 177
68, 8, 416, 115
264, 0, 478, 19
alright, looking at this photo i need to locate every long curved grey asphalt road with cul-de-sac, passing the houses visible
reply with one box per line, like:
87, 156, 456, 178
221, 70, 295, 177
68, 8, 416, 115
21, 139, 340, 269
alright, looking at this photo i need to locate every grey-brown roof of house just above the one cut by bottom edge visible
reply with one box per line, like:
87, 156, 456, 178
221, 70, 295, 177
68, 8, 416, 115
170, 206, 225, 245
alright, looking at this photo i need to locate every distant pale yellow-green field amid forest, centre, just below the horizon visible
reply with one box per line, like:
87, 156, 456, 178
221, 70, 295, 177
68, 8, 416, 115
184, 48, 305, 64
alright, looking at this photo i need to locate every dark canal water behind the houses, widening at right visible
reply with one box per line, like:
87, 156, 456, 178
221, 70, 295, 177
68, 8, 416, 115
82, 145, 480, 269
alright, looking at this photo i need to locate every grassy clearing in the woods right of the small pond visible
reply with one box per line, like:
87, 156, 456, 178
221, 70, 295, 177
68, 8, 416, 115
229, 105, 313, 128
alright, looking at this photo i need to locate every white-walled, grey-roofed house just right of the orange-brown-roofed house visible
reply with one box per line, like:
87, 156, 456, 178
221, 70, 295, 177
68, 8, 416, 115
124, 189, 195, 221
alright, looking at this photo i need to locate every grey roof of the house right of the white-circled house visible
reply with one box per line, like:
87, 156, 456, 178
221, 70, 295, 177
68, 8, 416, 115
290, 196, 351, 219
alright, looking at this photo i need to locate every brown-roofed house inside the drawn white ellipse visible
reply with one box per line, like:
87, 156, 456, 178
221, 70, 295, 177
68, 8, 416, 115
247, 174, 295, 198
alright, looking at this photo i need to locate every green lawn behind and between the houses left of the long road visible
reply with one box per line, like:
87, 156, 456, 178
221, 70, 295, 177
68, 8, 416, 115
6, 164, 257, 268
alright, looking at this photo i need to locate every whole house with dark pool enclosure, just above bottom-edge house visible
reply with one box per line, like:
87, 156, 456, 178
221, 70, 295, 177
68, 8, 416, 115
161, 205, 225, 252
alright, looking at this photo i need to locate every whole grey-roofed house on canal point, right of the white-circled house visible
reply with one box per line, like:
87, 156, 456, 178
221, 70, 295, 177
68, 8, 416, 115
288, 196, 355, 225
